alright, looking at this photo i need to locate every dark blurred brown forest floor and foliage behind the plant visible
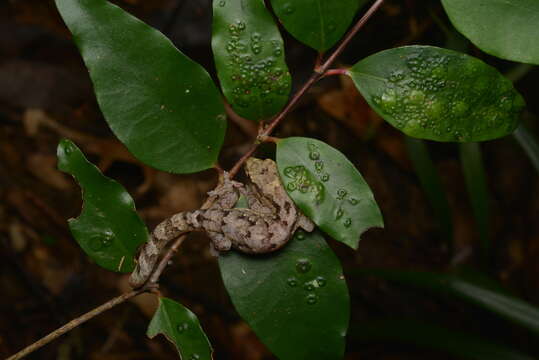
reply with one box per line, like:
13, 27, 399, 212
0, 0, 539, 360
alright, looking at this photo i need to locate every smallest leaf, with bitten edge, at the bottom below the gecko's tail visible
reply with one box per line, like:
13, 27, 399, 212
150, 297, 212, 360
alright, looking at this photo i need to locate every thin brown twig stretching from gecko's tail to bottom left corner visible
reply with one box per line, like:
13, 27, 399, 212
6, 287, 149, 360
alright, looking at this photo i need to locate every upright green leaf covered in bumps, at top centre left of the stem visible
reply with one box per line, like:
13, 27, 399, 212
212, 0, 291, 120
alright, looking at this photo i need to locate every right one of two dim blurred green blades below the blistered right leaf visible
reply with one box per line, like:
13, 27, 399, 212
459, 143, 490, 260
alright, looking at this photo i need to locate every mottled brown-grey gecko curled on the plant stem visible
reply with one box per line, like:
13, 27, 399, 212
130, 158, 314, 288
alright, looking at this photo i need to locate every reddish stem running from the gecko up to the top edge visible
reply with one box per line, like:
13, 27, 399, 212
230, 0, 384, 177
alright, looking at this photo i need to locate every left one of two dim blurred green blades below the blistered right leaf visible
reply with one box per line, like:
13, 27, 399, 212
405, 136, 453, 246
